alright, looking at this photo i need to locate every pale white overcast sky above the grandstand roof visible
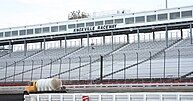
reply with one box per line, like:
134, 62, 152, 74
0, 0, 193, 29
